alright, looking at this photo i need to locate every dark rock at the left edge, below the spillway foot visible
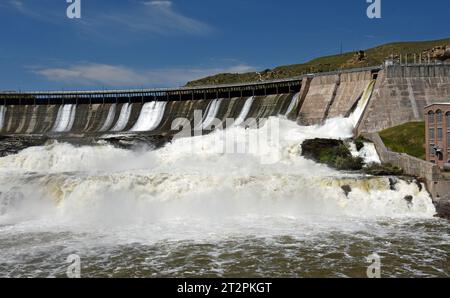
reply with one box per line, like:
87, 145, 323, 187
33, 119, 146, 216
0, 136, 48, 157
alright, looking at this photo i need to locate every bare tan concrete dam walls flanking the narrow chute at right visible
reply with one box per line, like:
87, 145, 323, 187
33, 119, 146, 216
297, 64, 450, 133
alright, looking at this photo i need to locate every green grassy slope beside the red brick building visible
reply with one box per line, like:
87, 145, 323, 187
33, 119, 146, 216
380, 122, 425, 159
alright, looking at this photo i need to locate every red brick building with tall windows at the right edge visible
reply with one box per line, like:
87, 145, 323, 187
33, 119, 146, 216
425, 103, 450, 168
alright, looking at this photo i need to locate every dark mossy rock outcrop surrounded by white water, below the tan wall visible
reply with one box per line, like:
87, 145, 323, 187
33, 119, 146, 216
302, 138, 363, 171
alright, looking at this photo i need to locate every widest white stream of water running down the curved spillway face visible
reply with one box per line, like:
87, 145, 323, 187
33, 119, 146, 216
131, 101, 167, 132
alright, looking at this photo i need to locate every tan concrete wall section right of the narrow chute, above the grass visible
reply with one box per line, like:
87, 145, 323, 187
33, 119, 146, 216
358, 65, 450, 132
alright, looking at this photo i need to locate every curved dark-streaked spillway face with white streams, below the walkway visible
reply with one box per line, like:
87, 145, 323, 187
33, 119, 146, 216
0, 93, 295, 135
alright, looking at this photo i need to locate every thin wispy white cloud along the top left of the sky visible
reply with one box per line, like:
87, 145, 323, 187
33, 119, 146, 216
5, 0, 213, 39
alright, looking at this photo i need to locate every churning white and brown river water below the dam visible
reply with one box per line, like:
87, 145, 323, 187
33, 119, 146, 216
0, 117, 450, 277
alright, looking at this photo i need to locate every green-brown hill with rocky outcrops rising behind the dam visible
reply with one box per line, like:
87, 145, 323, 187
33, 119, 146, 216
186, 38, 450, 87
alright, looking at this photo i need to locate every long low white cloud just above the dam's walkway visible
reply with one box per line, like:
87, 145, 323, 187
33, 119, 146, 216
34, 63, 255, 88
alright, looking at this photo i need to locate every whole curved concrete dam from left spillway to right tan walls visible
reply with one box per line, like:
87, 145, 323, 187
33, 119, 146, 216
0, 64, 450, 135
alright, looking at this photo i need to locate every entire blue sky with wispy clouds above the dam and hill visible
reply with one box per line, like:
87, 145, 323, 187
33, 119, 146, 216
0, 0, 450, 91
